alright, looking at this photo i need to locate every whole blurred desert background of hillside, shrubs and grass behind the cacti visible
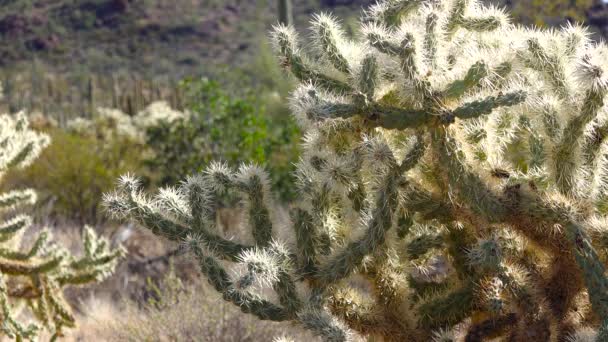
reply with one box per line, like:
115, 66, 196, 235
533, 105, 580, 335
0, 0, 608, 341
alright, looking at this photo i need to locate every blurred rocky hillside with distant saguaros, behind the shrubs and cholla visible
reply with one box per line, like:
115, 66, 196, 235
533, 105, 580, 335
0, 0, 608, 121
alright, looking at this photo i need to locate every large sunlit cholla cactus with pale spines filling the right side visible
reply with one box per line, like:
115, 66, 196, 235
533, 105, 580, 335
106, 0, 608, 341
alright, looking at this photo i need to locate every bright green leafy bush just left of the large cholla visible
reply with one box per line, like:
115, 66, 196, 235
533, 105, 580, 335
146, 79, 299, 198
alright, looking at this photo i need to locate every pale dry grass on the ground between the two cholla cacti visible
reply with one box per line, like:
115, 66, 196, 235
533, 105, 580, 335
69, 282, 315, 342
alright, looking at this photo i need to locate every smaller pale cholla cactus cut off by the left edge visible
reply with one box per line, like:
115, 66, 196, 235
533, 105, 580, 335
0, 114, 123, 341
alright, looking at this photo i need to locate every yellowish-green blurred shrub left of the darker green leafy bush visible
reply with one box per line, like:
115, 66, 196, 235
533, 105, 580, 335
7, 111, 143, 224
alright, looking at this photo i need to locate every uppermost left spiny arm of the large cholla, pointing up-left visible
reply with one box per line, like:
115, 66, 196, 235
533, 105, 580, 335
273, 25, 353, 94
